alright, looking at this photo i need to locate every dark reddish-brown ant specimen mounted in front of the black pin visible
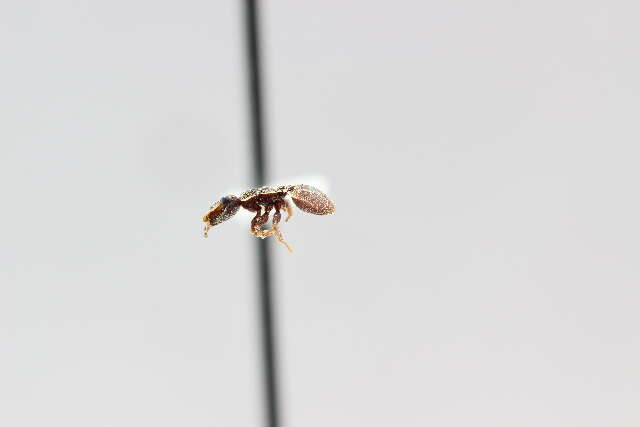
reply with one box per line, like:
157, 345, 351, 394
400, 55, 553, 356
202, 184, 336, 252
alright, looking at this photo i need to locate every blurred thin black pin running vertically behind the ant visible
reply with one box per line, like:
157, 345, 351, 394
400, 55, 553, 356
245, 0, 279, 427
